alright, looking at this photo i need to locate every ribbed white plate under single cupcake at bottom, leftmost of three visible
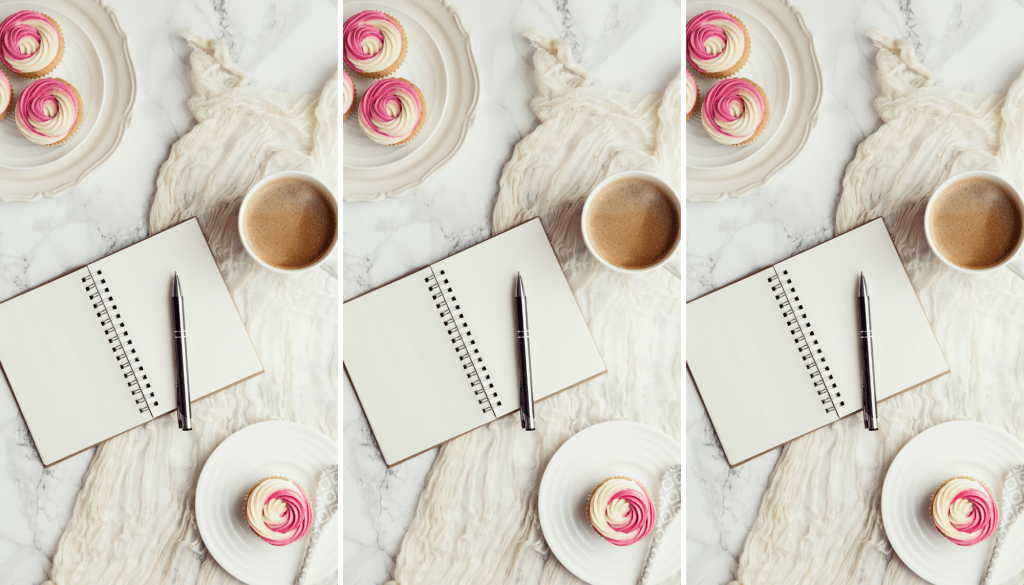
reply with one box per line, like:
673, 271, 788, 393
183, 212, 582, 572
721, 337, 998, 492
196, 420, 338, 585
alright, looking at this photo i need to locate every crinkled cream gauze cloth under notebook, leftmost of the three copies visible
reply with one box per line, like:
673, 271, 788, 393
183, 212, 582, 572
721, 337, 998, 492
46, 30, 338, 585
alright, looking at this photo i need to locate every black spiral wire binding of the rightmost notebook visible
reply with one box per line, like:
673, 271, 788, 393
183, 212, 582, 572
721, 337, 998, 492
768, 268, 846, 413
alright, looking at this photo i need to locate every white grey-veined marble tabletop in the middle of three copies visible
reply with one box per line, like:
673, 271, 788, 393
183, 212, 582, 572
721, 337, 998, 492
342, 0, 682, 585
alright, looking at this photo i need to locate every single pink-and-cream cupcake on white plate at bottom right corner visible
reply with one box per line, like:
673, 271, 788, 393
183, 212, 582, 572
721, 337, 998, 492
931, 475, 999, 546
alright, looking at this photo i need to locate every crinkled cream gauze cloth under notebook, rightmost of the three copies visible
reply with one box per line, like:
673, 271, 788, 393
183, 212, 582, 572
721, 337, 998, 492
734, 29, 1024, 585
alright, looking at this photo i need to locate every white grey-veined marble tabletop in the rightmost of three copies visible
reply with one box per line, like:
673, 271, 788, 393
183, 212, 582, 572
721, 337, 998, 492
684, 0, 1024, 585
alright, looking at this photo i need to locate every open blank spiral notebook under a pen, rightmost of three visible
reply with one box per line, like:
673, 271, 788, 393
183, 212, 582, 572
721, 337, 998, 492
686, 219, 949, 466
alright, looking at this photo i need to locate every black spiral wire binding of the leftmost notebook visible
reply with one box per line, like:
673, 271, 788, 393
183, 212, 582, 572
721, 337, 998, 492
82, 267, 151, 412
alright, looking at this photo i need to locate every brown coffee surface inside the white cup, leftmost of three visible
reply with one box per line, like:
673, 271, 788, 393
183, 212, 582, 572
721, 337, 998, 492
245, 178, 338, 269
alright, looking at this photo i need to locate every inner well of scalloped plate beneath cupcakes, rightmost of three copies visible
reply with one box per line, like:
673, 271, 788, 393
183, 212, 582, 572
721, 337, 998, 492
686, 2, 791, 169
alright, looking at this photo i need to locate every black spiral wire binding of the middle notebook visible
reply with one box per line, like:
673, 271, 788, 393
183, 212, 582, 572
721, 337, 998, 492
424, 267, 502, 413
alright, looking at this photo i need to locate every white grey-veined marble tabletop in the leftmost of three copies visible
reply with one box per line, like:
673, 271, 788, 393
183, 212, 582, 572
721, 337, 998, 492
0, 0, 339, 585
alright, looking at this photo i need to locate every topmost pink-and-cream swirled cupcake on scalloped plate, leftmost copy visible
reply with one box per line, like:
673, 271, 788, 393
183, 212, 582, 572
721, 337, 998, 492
0, 10, 63, 79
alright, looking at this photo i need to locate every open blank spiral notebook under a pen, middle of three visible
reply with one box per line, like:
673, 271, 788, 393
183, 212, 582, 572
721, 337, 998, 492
344, 219, 605, 466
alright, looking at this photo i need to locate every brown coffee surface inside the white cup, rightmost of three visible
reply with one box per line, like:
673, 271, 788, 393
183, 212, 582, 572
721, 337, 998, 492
930, 177, 1024, 269
